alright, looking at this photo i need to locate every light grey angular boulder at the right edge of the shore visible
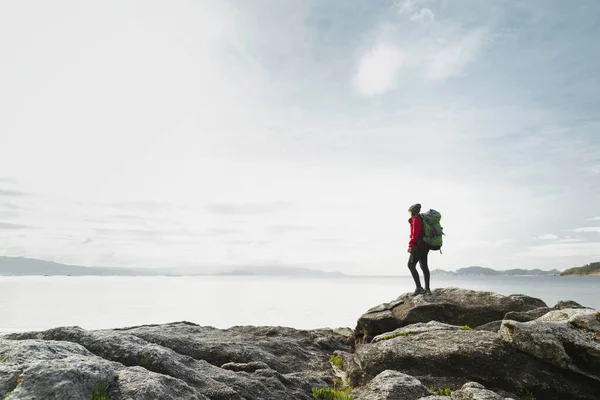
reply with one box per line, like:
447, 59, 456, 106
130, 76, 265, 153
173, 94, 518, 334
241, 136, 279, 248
500, 308, 600, 382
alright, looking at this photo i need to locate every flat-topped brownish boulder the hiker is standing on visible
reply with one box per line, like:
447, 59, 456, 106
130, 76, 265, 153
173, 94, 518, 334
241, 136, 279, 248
355, 288, 547, 343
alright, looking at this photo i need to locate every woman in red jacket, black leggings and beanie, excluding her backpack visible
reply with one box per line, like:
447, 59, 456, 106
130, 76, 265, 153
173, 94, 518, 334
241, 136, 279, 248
408, 203, 431, 295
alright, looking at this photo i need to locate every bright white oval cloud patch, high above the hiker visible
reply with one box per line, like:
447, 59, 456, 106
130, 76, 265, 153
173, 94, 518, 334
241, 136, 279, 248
355, 44, 404, 97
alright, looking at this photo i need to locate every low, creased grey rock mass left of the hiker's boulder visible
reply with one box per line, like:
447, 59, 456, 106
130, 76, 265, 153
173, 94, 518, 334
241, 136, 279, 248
0, 323, 354, 400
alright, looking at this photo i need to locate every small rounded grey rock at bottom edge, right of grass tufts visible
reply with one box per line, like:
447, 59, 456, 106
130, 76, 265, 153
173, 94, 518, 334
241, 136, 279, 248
353, 370, 432, 400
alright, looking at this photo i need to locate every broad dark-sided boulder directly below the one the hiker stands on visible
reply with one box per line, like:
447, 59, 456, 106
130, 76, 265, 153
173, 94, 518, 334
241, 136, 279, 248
345, 326, 600, 400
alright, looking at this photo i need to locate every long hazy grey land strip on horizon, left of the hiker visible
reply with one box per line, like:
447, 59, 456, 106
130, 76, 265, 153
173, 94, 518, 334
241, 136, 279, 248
0, 256, 345, 277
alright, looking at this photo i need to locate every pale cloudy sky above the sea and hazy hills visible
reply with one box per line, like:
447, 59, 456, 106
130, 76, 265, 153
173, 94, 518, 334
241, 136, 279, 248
0, 0, 600, 275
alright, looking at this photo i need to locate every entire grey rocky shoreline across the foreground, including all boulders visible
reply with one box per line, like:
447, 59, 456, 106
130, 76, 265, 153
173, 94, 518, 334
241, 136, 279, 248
0, 288, 600, 400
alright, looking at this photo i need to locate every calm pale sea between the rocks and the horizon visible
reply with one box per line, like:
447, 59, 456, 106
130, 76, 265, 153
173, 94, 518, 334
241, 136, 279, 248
0, 276, 600, 331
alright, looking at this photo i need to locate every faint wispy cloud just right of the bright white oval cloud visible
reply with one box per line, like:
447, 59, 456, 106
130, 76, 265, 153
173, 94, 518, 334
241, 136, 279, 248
426, 29, 488, 80
